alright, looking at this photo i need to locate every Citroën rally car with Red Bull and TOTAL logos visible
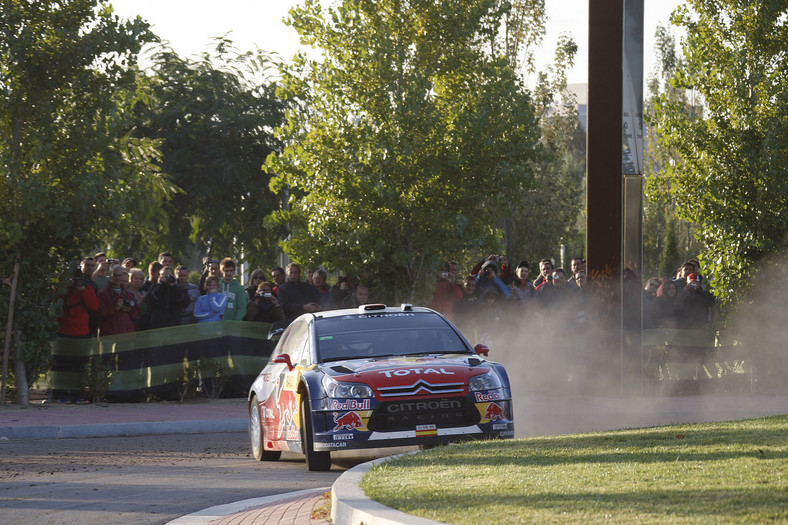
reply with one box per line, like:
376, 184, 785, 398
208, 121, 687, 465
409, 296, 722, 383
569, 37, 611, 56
249, 304, 514, 470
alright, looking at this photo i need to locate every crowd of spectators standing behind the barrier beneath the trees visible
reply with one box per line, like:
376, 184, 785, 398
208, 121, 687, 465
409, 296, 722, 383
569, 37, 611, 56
58, 252, 714, 338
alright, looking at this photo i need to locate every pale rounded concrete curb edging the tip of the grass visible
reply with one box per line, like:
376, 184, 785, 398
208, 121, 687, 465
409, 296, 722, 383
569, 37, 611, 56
331, 452, 440, 525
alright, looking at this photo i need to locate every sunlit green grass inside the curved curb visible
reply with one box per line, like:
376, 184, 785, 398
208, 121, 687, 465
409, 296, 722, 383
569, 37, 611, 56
362, 416, 788, 525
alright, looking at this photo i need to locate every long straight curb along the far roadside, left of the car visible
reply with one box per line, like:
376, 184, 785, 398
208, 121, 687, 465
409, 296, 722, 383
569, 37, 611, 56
0, 419, 249, 440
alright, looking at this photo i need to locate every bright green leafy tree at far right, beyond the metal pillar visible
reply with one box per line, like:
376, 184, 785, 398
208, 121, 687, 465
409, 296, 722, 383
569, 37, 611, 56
653, 0, 788, 302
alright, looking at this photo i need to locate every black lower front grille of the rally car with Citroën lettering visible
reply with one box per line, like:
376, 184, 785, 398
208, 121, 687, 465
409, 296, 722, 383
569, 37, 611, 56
367, 397, 480, 432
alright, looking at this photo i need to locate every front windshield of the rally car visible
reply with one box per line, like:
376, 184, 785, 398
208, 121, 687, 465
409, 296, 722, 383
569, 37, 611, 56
315, 312, 472, 362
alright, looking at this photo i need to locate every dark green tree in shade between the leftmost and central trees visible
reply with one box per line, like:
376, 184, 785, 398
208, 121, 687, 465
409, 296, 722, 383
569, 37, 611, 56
129, 42, 284, 261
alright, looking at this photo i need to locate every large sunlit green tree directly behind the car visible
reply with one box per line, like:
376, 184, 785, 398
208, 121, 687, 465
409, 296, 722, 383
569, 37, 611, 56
267, 0, 541, 299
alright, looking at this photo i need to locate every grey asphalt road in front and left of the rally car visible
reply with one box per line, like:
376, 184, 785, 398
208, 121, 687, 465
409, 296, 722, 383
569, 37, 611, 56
0, 432, 344, 525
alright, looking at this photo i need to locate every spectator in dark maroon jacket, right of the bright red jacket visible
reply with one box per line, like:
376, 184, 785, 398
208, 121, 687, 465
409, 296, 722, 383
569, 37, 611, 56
96, 264, 140, 336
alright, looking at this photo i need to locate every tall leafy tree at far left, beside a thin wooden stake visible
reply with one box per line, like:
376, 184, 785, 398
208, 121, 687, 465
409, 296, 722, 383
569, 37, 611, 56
0, 0, 172, 402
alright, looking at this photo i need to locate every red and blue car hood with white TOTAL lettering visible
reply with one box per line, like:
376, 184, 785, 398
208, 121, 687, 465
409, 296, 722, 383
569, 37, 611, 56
320, 354, 490, 395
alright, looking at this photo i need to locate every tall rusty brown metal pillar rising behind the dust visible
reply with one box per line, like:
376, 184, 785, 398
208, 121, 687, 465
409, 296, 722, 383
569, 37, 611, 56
586, 0, 624, 391
